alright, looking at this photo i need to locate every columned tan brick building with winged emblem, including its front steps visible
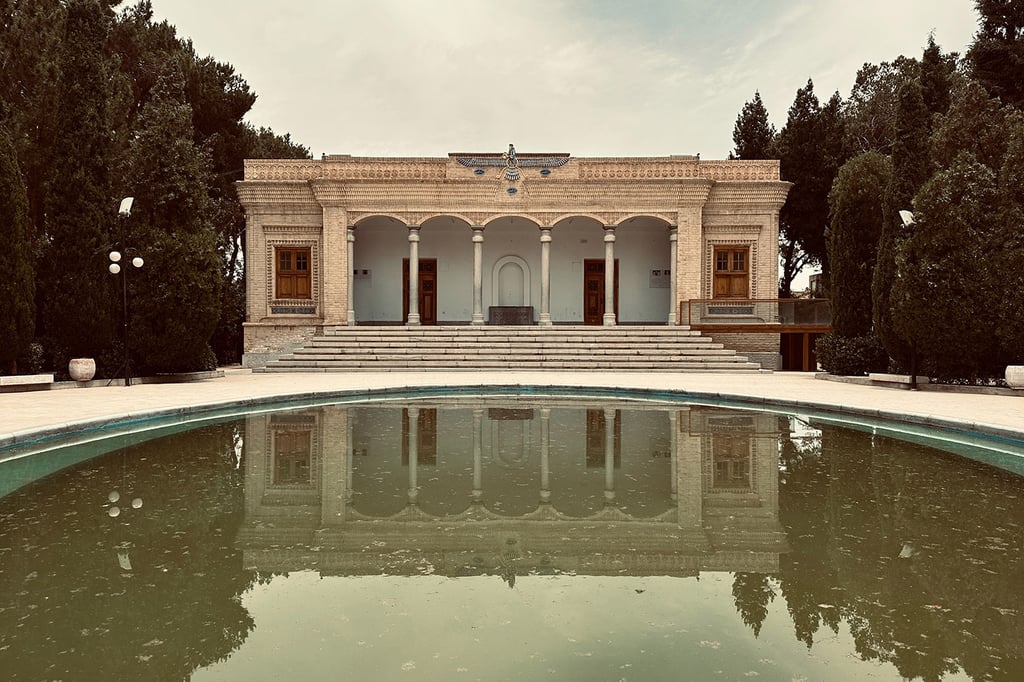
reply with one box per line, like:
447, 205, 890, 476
238, 144, 814, 371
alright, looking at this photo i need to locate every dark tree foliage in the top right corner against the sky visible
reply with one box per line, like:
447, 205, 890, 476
967, 0, 1024, 109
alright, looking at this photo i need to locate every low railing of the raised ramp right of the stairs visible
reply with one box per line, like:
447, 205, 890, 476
679, 298, 831, 327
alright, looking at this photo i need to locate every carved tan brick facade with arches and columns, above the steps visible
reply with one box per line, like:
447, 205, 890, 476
238, 148, 790, 364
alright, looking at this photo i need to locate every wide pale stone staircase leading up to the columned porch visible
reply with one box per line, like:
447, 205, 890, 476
253, 326, 761, 373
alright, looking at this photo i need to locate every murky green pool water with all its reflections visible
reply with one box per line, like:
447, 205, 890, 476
0, 397, 1024, 680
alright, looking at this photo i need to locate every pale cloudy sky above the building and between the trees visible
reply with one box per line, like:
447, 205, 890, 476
146, 0, 977, 159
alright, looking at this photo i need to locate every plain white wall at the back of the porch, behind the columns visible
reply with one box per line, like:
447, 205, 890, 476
353, 212, 670, 324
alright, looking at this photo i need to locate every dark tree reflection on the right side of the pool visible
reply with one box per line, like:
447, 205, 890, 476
778, 427, 1024, 680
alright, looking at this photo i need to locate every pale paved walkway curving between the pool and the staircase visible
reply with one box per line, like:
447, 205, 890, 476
0, 369, 1024, 448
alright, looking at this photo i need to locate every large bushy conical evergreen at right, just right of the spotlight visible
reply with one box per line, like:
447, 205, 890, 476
890, 153, 1007, 377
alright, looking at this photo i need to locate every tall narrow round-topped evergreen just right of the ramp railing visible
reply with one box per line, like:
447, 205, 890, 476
826, 152, 892, 336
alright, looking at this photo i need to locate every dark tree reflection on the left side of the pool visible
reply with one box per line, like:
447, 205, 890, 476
0, 424, 254, 680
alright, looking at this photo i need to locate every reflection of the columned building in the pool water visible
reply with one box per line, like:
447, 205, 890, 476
239, 399, 787, 585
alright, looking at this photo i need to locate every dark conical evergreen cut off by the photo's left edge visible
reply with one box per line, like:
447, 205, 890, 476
0, 127, 36, 374
